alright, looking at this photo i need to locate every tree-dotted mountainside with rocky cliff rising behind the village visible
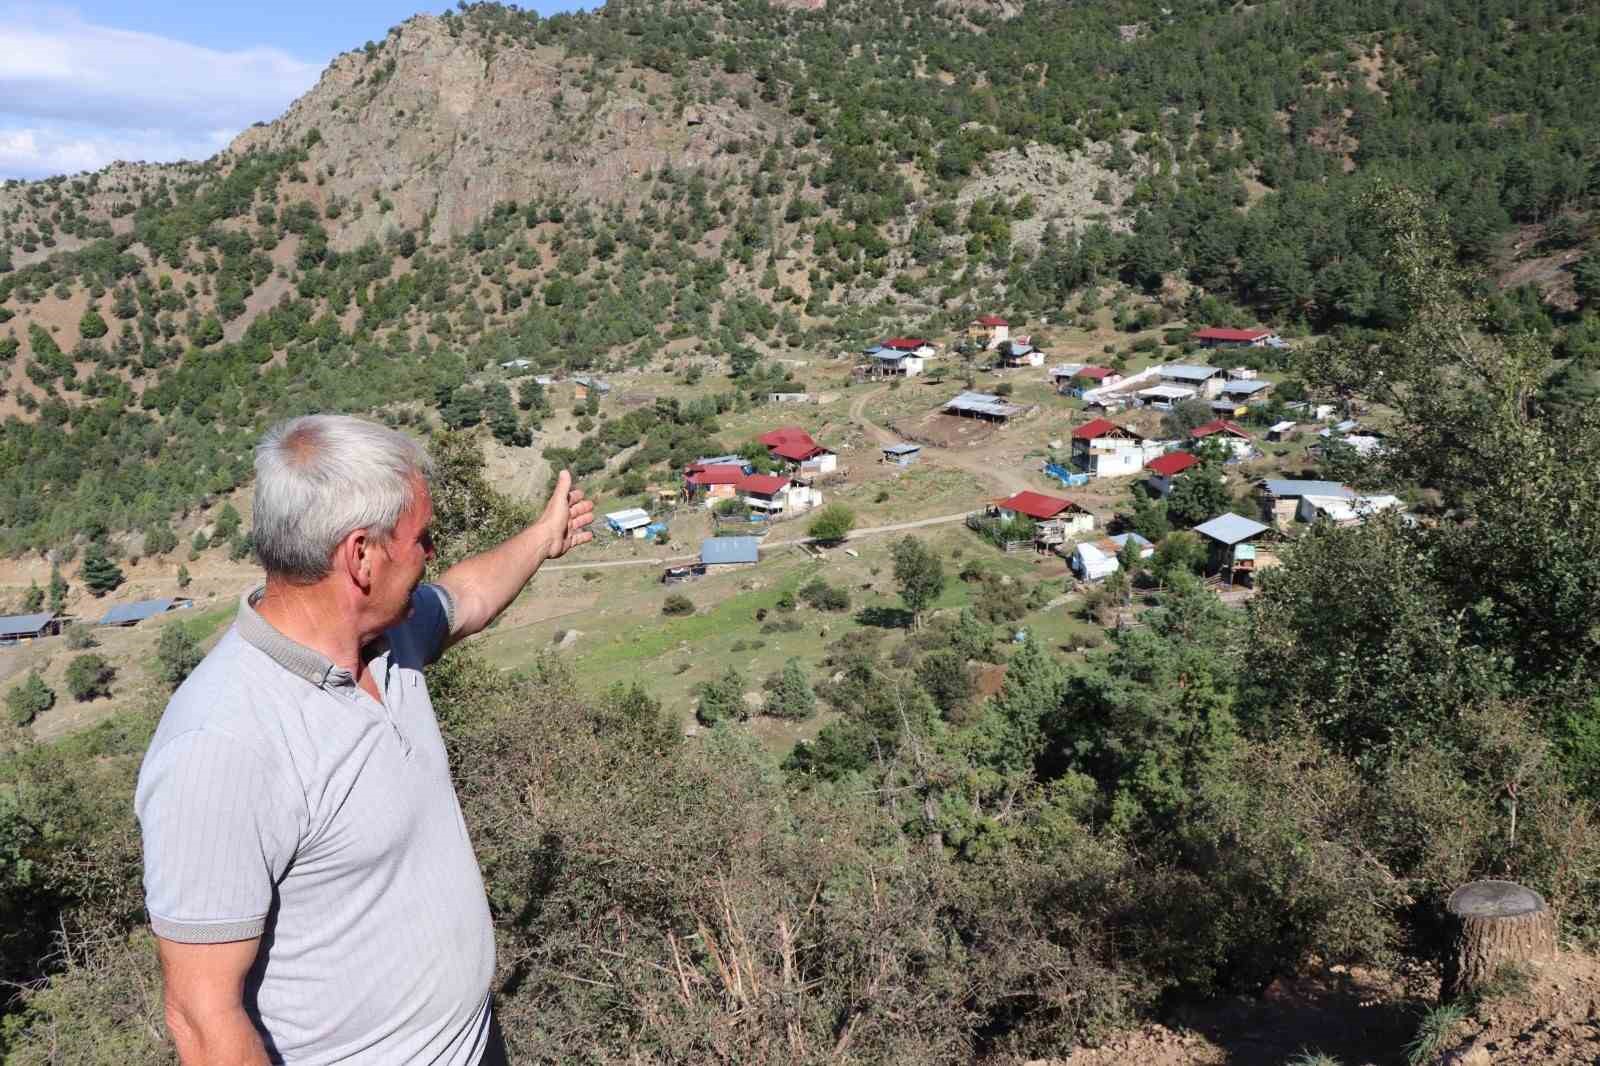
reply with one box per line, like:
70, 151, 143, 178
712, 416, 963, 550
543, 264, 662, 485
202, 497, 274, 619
0, 0, 1600, 552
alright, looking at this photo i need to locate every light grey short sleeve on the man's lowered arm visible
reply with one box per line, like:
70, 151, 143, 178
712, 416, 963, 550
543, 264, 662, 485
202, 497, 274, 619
134, 730, 304, 944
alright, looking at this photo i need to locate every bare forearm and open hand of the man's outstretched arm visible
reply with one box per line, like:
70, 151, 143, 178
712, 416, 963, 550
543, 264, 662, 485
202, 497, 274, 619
438, 471, 595, 643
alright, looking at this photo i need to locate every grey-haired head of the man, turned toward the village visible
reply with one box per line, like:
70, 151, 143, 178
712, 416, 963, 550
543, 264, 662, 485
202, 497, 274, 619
253, 415, 434, 623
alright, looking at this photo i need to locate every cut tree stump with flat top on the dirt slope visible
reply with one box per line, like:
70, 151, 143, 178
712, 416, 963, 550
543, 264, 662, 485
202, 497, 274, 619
1440, 880, 1555, 1002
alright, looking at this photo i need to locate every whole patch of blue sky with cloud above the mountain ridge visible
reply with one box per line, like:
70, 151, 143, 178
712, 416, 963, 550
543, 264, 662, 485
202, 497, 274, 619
0, 0, 589, 178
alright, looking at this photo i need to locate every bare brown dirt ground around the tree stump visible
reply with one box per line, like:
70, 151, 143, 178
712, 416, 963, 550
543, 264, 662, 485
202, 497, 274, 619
1029, 952, 1600, 1066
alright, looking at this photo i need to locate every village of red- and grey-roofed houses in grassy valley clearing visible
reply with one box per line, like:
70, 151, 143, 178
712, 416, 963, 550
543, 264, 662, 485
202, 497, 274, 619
0, 314, 1405, 747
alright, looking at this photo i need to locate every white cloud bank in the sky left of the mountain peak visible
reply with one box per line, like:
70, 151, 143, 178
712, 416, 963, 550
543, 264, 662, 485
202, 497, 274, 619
0, 6, 320, 178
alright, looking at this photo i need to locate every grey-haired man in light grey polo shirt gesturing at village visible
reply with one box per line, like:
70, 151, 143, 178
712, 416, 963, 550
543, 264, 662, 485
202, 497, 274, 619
136, 415, 594, 1066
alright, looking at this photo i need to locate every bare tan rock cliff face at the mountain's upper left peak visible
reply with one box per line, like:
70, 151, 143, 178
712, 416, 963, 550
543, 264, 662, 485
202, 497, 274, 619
229, 16, 790, 248
